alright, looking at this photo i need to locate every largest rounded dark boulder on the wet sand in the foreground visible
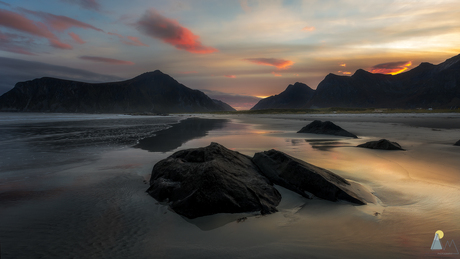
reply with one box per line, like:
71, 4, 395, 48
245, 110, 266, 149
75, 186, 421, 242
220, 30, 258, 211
147, 143, 281, 218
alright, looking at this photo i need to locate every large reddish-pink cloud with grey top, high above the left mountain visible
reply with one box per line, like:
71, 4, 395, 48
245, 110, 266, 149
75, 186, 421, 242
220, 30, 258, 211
137, 9, 217, 54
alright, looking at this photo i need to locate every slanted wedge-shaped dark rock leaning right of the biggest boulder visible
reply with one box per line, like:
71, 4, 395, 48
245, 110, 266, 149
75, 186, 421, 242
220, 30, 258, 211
252, 149, 366, 205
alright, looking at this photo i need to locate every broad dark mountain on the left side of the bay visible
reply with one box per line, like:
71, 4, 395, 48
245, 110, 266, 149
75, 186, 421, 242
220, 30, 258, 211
0, 70, 235, 113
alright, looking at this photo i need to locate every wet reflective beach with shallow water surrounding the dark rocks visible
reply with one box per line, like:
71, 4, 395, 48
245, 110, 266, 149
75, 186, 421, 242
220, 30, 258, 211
0, 113, 460, 259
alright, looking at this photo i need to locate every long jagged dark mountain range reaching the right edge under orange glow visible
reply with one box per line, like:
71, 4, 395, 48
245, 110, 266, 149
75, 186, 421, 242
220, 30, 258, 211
252, 55, 460, 110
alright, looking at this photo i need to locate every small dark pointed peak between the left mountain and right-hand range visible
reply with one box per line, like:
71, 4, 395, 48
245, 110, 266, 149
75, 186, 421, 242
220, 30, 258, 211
251, 82, 315, 110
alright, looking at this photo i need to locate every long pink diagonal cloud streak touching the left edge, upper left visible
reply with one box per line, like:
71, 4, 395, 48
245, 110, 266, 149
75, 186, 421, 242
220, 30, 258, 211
0, 9, 72, 49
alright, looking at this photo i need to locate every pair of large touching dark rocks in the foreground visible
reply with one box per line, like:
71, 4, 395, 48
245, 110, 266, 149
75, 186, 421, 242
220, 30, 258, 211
147, 143, 366, 218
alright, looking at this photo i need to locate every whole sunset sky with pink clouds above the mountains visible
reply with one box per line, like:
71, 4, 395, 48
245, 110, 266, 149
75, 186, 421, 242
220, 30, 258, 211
0, 0, 460, 110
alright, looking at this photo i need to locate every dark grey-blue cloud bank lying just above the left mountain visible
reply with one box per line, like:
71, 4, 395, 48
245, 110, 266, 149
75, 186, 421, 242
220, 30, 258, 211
0, 57, 124, 94
